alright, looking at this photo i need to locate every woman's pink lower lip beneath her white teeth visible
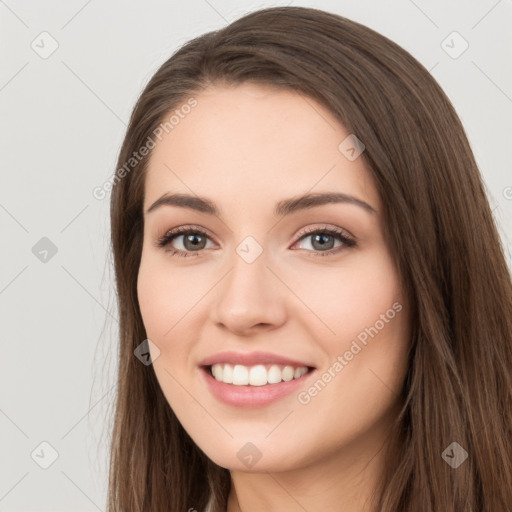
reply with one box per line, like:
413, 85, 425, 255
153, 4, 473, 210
201, 367, 316, 407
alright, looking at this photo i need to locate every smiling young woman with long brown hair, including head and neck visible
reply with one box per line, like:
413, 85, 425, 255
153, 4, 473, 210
109, 7, 512, 512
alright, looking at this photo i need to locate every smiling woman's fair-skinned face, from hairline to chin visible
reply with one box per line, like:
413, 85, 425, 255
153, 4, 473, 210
138, 84, 409, 472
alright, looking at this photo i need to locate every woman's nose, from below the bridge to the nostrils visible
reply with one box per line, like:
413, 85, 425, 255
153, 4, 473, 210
211, 247, 289, 336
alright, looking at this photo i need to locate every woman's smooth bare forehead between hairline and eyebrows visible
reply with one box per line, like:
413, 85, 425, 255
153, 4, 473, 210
145, 84, 378, 214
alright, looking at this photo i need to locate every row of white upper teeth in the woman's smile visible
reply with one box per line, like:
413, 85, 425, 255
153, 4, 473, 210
211, 364, 308, 386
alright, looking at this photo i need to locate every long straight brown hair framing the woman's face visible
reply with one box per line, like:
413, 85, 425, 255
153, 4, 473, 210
108, 7, 512, 512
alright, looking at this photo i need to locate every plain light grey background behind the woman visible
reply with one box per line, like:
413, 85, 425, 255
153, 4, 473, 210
0, 0, 512, 512
